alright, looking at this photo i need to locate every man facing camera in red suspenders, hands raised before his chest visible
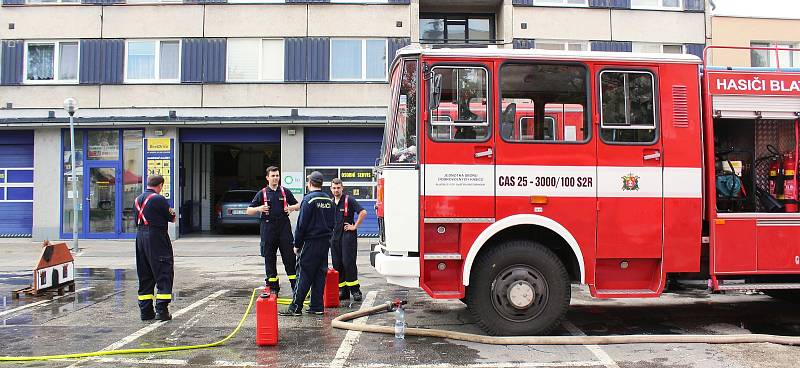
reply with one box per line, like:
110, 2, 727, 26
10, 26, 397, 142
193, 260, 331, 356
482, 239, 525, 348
247, 166, 300, 294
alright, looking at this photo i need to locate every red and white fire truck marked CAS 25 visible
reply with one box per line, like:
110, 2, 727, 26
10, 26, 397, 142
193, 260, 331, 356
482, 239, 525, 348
371, 47, 800, 335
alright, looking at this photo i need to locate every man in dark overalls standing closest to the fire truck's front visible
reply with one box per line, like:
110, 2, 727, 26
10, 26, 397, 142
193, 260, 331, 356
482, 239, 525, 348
331, 178, 367, 302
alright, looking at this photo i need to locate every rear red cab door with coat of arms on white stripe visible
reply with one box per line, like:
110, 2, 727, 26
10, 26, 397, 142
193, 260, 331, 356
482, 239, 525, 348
595, 66, 664, 258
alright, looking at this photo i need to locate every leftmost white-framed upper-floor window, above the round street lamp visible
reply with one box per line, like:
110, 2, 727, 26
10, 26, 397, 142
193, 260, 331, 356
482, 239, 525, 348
25, 41, 79, 83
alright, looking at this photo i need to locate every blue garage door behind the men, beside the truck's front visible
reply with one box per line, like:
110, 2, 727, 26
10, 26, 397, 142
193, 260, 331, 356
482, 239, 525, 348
303, 128, 383, 237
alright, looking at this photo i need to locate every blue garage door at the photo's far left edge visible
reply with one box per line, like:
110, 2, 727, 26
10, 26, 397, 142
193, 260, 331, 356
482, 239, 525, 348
0, 130, 33, 238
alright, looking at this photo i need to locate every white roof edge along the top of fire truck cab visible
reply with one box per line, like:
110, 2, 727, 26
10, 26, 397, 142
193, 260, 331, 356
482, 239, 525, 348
397, 45, 702, 64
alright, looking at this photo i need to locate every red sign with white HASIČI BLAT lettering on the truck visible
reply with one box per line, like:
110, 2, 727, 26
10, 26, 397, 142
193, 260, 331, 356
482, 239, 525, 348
708, 72, 800, 96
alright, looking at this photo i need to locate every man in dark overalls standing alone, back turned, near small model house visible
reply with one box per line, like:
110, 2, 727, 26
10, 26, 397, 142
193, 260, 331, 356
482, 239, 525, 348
134, 175, 175, 321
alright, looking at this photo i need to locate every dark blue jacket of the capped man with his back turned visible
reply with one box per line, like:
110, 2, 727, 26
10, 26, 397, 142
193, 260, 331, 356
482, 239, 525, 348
294, 191, 335, 248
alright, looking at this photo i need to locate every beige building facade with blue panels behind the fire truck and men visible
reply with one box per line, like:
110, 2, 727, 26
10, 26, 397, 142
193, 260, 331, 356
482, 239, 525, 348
0, 0, 706, 240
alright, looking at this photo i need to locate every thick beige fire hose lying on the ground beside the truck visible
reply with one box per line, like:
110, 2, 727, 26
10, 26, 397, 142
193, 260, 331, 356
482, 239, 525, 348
331, 302, 800, 345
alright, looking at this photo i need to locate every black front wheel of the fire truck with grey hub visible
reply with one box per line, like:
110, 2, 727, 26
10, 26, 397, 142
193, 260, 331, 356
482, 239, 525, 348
466, 240, 570, 336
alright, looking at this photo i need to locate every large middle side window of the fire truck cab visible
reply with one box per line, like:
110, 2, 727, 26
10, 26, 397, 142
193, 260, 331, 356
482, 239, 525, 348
500, 63, 589, 142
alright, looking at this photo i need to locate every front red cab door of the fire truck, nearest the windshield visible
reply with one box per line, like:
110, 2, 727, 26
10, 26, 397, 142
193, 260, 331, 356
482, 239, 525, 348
422, 62, 495, 222
